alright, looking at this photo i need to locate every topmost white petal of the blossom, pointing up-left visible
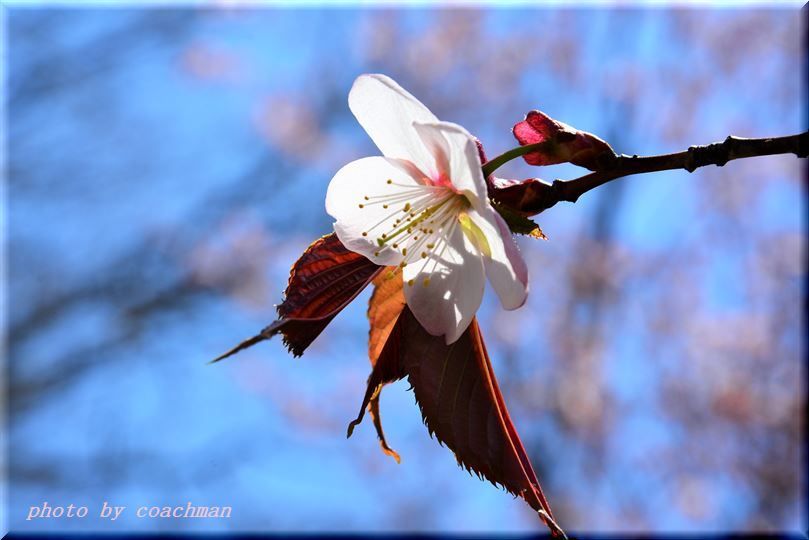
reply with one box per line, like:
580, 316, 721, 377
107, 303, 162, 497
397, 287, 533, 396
348, 74, 438, 176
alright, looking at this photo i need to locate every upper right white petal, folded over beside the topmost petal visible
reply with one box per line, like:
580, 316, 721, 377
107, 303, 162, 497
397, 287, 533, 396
410, 122, 487, 205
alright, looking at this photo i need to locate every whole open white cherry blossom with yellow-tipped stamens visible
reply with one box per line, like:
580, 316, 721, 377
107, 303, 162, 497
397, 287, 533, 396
326, 75, 528, 344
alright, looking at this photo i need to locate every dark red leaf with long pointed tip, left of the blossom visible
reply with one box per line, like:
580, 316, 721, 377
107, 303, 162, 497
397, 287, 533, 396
213, 234, 382, 362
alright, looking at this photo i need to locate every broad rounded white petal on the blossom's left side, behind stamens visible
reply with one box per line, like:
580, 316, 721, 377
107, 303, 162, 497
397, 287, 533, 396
326, 157, 434, 266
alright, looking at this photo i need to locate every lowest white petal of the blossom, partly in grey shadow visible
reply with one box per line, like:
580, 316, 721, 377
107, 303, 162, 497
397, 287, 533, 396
402, 222, 486, 345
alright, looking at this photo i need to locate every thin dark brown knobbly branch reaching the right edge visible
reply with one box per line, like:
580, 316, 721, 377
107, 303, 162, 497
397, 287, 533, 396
520, 131, 809, 213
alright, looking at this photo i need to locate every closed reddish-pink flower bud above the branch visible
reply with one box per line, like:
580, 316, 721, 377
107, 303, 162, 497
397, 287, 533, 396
512, 111, 615, 171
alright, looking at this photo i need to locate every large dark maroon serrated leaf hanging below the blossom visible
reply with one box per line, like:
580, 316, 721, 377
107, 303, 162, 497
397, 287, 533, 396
349, 307, 564, 535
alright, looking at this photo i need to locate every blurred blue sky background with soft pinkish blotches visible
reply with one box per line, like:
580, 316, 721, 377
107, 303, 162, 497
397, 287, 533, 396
6, 2, 807, 532
